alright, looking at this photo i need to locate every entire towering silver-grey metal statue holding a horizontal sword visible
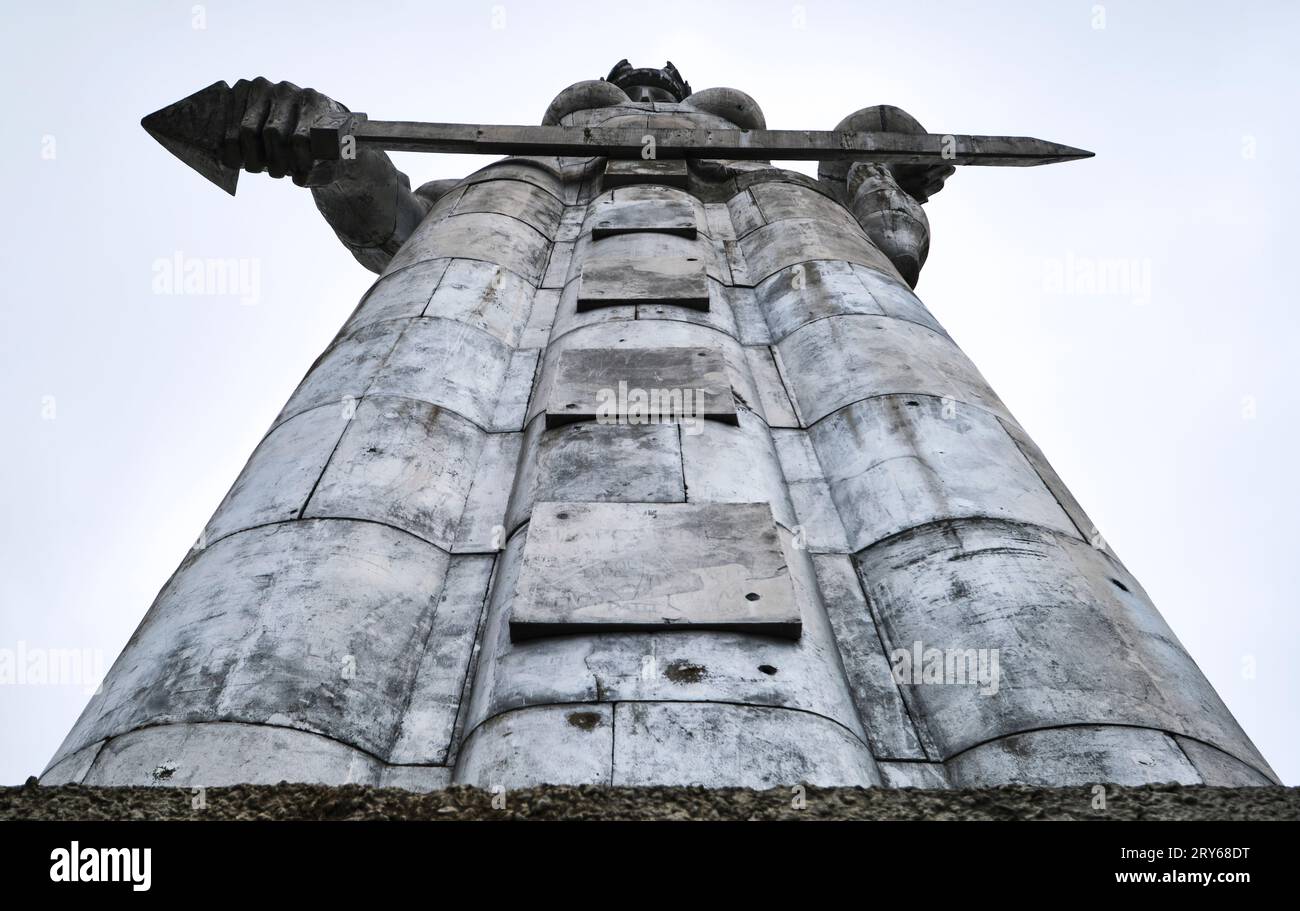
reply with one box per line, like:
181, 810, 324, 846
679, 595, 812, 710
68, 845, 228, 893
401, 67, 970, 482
42, 64, 1277, 790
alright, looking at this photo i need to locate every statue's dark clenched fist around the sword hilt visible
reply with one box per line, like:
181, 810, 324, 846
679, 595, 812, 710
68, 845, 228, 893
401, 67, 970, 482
221, 77, 352, 187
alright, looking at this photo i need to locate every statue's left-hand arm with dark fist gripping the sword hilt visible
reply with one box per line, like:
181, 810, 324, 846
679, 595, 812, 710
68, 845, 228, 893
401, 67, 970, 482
222, 77, 437, 272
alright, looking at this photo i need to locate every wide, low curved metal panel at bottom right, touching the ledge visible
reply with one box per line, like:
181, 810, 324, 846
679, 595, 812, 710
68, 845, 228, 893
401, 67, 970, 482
946, 725, 1201, 788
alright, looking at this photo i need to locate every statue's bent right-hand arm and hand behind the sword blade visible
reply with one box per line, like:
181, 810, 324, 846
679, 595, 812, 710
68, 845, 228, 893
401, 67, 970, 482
818, 105, 957, 287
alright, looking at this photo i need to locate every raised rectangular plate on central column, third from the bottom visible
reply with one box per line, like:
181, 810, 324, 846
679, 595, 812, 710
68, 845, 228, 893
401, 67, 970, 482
577, 256, 709, 311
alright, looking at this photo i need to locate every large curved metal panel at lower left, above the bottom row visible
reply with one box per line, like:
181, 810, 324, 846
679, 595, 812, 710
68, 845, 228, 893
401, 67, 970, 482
49, 520, 449, 777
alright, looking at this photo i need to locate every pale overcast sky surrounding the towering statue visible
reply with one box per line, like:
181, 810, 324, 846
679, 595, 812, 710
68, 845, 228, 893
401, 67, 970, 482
0, 0, 1300, 784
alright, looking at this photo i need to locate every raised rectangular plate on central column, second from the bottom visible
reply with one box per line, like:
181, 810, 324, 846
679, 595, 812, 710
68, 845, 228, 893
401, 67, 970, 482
546, 348, 736, 428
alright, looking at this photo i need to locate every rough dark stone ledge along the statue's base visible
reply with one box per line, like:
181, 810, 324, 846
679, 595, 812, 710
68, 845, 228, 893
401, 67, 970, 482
0, 778, 1300, 821
